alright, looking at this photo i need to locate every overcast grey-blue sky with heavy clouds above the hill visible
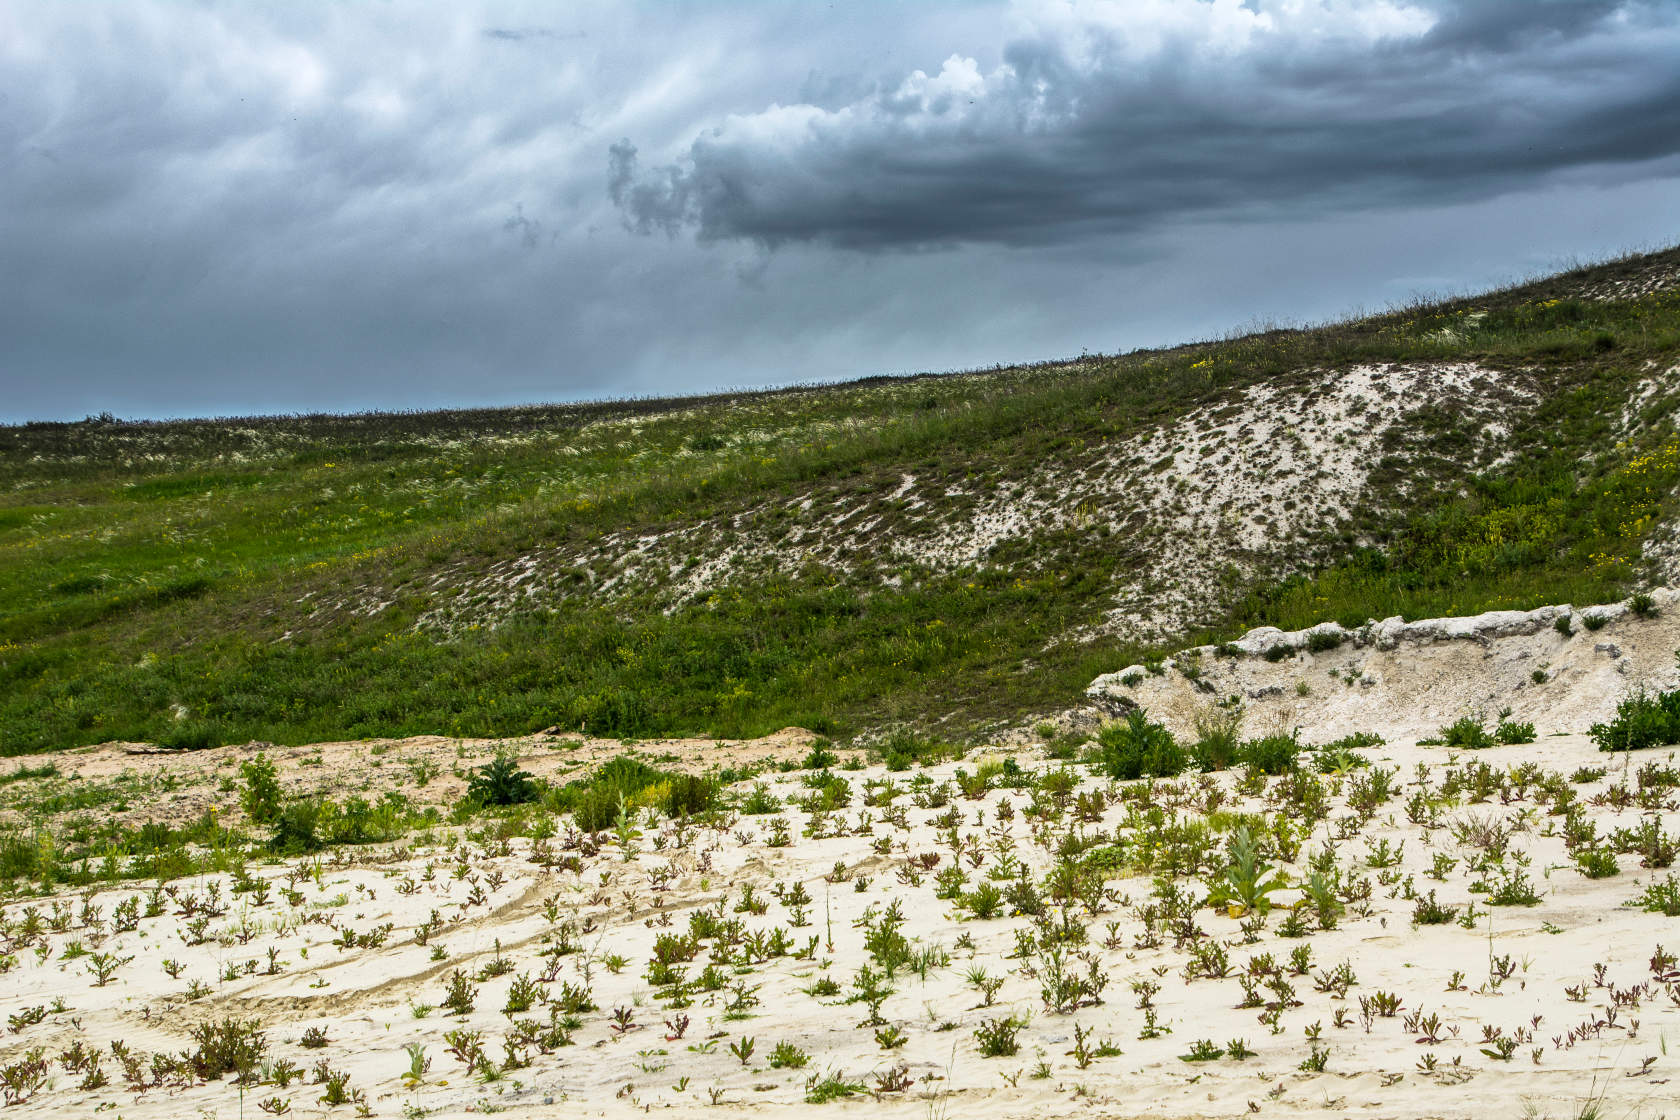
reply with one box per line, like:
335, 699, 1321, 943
0, 0, 1680, 421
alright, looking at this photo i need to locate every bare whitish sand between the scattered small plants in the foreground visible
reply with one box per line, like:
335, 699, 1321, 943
0, 718, 1680, 1118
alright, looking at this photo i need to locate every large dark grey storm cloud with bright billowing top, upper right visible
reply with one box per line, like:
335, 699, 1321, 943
608, 0, 1680, 250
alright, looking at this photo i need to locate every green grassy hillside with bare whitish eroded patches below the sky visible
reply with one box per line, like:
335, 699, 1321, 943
0, 250, 1680, 754
